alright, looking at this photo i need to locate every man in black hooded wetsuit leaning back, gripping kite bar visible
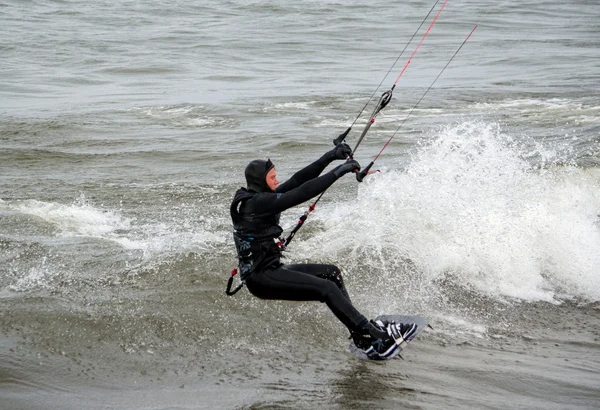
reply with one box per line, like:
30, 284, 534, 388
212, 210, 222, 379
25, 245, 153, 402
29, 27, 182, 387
231, 144, 417, 359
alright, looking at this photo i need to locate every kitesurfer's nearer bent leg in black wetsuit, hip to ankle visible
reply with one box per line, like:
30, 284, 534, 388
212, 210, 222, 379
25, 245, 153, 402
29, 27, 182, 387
246, 265, 367, 331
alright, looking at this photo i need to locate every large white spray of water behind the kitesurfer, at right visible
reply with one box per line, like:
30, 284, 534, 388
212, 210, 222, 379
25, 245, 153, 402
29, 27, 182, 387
305, 122, 600, 301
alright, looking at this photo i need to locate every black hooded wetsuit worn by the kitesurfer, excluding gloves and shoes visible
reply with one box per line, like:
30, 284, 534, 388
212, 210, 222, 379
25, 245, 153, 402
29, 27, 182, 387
231, 153, 368, 332
